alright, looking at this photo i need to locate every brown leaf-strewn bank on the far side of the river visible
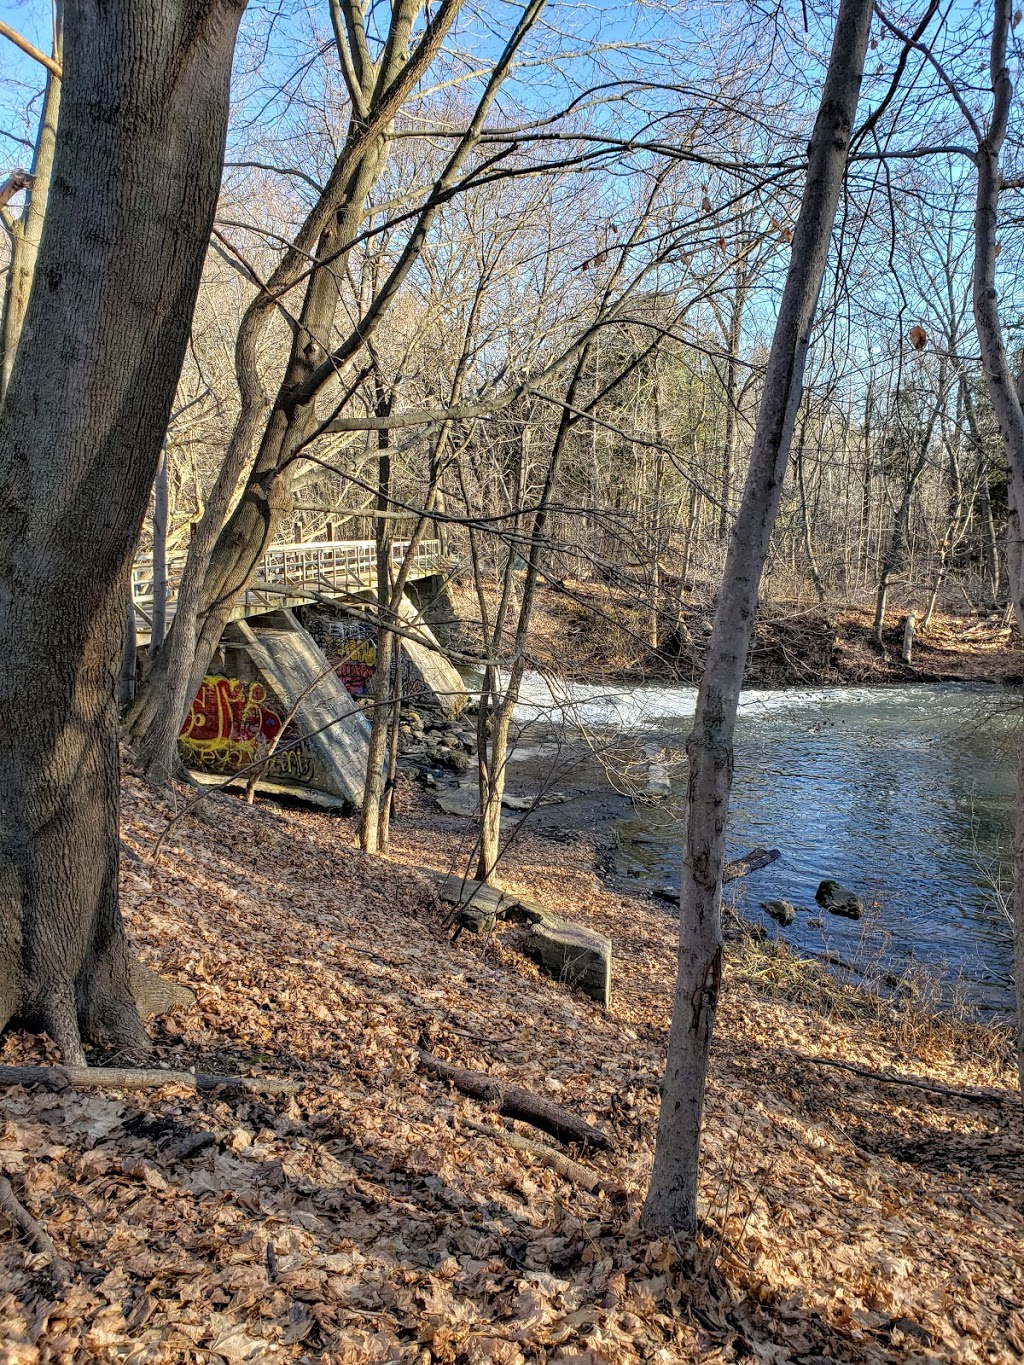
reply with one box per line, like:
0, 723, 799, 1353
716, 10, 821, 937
459, 581, 1024, 687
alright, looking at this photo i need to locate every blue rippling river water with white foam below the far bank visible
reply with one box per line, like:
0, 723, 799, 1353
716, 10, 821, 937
512, 677, 1019, 1014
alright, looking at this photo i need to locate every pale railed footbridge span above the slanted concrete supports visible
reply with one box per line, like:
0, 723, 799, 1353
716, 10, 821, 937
131, 541, 451, 644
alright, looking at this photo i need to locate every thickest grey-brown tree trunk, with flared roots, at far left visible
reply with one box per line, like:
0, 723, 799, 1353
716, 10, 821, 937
0, 0, 243, 1063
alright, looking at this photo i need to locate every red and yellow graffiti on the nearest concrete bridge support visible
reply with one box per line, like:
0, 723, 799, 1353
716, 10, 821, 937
177, 674, 314, 782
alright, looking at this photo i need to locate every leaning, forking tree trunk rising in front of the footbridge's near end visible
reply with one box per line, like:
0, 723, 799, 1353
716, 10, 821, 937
128, 0, 521, 781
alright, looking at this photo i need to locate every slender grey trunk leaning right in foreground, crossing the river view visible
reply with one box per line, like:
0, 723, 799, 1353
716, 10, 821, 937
642, 0, 872, 1235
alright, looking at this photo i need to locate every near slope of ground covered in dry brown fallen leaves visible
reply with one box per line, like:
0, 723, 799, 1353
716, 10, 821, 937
0, 775, 1024, 1365
